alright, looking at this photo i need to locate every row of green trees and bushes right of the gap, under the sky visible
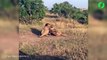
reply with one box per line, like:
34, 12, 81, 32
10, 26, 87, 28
51, 1, 88, 23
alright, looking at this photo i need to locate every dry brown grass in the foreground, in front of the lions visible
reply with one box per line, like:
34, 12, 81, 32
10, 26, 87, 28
20, 24, 88, 60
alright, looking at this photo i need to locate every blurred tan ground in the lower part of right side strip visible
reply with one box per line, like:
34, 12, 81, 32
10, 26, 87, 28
88, 16, 107, 60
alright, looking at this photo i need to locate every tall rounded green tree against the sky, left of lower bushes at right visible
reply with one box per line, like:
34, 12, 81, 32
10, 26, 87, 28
51, 1, 72, 18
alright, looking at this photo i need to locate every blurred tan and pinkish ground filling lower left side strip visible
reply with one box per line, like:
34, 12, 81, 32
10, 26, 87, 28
0, 18, 19, 60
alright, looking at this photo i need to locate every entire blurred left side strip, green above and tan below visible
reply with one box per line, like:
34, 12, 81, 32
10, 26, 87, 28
0, 0, 19, 60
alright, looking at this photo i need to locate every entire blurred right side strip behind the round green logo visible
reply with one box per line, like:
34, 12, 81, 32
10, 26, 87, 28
88, 0, 107, 60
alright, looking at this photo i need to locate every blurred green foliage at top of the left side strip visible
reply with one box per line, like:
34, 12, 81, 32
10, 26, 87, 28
0, 0, 18, 20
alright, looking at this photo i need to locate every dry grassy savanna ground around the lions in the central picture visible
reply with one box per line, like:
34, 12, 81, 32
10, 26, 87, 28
19, 13, 88, 60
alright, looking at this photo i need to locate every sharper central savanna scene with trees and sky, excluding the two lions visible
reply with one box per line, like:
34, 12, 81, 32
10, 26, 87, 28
19, 0, 88, 60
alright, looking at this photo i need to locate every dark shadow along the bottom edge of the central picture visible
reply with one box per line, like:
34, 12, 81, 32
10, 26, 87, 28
19, 51, 66, 60
